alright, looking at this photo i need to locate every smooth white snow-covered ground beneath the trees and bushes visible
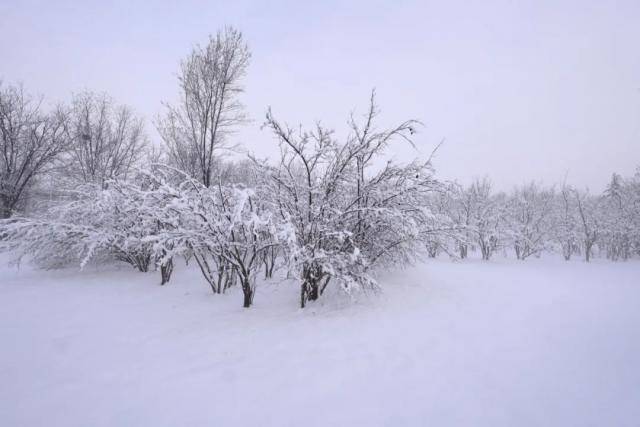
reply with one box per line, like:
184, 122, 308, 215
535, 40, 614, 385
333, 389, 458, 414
0, 259, 640, 426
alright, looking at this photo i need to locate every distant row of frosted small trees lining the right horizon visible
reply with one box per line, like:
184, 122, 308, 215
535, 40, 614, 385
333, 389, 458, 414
438, 172, 640, 261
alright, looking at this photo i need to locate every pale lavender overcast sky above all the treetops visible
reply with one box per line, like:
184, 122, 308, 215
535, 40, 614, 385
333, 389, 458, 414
0, 0, 640, 190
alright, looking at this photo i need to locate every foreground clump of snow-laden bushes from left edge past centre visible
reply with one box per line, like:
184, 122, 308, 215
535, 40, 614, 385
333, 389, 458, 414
1, 93, 453, 307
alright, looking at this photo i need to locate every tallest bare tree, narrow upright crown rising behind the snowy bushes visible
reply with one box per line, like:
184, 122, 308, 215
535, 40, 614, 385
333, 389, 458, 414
158, 27, 251, 187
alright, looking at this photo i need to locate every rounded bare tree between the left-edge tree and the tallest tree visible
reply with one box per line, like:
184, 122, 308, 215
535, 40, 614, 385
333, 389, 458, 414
65, 92, 147, 186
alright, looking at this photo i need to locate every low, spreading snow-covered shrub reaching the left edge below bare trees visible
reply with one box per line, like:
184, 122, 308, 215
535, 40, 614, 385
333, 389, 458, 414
0, 177, 165, 272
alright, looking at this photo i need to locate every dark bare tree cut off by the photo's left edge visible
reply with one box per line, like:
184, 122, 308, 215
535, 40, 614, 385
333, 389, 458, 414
0, 83, 68, 218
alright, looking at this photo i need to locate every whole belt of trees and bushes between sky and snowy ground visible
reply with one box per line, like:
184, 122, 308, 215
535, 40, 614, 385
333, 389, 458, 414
0, 28, 640, 307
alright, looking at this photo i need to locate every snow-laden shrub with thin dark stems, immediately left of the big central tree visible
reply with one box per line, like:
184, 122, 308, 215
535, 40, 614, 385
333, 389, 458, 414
132, 168, 278, 307
